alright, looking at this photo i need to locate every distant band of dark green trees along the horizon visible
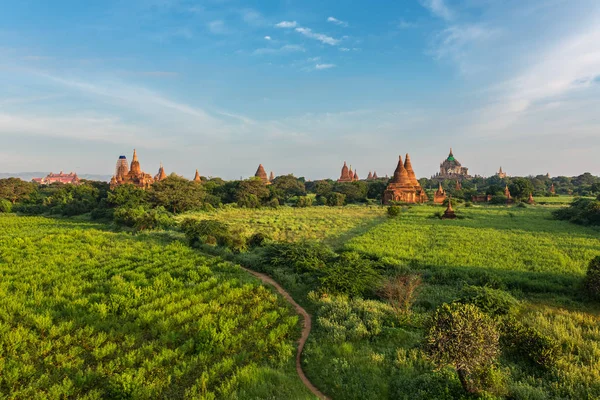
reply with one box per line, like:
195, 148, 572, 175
0, 173, 600, 228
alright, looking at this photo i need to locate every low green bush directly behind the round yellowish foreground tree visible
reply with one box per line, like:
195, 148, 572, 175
458, 285, 519, 317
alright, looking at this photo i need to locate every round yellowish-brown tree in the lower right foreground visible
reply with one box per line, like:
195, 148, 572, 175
425, 303, 499, 393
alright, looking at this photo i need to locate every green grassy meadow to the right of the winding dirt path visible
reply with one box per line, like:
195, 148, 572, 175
189, 205, 600, 400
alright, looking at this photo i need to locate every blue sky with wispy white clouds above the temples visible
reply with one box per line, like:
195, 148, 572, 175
0, 0, 600, 179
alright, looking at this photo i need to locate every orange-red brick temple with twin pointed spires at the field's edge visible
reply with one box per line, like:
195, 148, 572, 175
383, 154, 428, 204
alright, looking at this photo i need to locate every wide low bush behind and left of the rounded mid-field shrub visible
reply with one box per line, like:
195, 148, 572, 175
265, 242, 335, 273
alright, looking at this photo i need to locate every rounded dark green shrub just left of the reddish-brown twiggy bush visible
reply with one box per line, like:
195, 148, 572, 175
319, 252, 379, 296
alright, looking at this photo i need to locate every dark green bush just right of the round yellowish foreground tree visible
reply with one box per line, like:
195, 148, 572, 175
501, 318, 559, 368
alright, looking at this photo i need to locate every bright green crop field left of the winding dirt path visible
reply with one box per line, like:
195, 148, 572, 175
0, 214, 311, 399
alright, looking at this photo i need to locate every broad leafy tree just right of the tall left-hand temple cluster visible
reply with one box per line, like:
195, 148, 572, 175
148, 174, 206, 214
